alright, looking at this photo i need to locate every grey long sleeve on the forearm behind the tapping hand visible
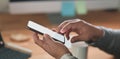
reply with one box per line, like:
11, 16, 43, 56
93, 28, 120, 56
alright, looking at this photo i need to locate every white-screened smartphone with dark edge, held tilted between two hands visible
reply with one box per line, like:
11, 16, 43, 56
27, 21, 65, 43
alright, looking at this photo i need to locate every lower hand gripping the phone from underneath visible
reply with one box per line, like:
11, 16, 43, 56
33, 33, 71, 59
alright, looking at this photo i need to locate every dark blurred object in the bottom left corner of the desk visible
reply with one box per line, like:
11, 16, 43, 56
0, 33, 31, 59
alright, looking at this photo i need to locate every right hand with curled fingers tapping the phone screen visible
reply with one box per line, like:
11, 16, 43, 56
57, 19, 103, 42
